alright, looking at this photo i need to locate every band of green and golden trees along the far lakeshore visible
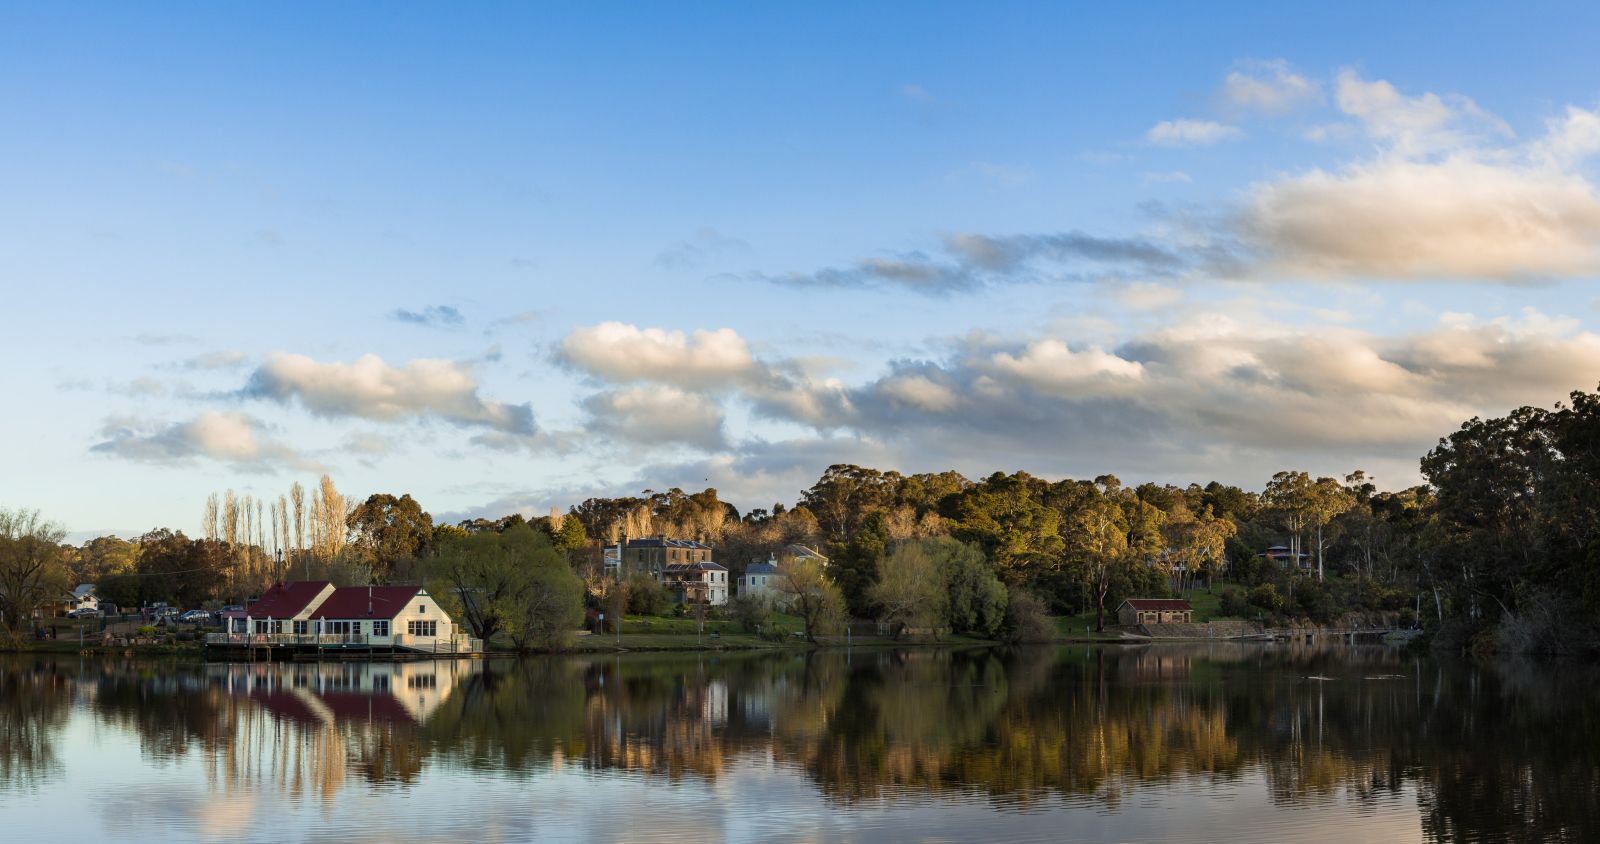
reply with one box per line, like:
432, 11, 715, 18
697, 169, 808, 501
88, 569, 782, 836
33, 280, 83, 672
9, 383, 1600, 651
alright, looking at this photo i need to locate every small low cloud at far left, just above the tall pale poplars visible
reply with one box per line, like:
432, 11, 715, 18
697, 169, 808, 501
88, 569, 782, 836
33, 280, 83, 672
90, 411, 320, 470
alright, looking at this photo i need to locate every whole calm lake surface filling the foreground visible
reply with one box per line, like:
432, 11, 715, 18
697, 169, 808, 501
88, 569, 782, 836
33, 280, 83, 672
0, 644, 1600, 844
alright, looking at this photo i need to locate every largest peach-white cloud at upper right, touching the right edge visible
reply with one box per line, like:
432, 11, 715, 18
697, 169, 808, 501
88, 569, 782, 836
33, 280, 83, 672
1237, 72, 1600, 281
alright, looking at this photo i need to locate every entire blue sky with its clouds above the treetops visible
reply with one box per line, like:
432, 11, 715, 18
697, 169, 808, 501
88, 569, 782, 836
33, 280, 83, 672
0, 3, 1600, 534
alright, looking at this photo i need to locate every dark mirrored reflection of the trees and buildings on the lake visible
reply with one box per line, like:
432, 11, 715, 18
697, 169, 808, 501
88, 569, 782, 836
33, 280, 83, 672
0, 643, 1600, 841
